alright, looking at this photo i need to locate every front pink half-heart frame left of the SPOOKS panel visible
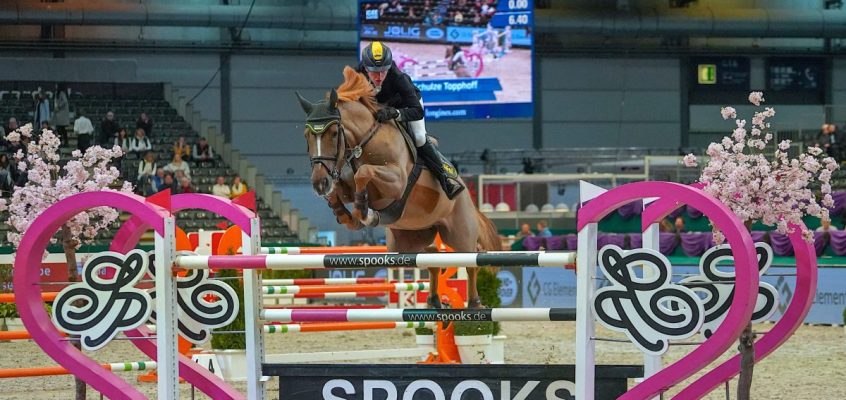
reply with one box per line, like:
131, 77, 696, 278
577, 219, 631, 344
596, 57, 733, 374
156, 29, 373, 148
14, 191, 169, 400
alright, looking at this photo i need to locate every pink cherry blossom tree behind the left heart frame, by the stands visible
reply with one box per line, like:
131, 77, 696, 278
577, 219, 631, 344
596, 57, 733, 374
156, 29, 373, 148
0, 124, 132, 399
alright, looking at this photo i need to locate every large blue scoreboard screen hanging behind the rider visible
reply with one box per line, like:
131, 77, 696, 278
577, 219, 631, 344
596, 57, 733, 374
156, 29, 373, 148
358, 0, 534, 120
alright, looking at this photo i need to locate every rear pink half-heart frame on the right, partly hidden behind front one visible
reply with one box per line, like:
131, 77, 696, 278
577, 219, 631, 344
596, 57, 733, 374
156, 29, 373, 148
642, 189, 817, 400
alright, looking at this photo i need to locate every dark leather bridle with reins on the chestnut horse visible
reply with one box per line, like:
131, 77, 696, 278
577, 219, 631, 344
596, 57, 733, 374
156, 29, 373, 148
306, 112, 382, 182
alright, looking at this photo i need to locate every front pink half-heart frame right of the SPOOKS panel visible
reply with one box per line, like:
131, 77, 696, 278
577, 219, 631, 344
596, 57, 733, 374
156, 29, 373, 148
578, 182, 758, 400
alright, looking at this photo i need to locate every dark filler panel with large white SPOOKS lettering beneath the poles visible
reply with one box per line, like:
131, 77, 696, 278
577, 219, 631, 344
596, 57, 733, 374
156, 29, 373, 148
262, 364, 643, 400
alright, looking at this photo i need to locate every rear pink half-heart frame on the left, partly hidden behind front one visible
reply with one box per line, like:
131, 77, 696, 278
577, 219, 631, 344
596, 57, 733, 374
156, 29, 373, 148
109, 193, 255, 400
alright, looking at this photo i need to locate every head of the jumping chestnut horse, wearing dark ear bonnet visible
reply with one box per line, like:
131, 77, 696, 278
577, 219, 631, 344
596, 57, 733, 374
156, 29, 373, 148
297, 89, 346, 196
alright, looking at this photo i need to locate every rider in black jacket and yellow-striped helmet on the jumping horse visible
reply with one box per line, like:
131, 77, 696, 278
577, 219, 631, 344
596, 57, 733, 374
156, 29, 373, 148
358, 42, 464, 199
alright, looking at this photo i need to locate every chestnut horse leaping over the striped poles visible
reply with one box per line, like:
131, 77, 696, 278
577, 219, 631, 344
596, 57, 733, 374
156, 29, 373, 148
297, 67, 501, 307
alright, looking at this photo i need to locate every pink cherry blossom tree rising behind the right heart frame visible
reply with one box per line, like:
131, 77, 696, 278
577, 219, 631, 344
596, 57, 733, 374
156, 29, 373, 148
684, 92, 839, 400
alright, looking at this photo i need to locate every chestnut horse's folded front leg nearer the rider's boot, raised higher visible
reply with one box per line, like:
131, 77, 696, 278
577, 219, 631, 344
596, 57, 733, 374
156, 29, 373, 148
352, 164, 406, 226
